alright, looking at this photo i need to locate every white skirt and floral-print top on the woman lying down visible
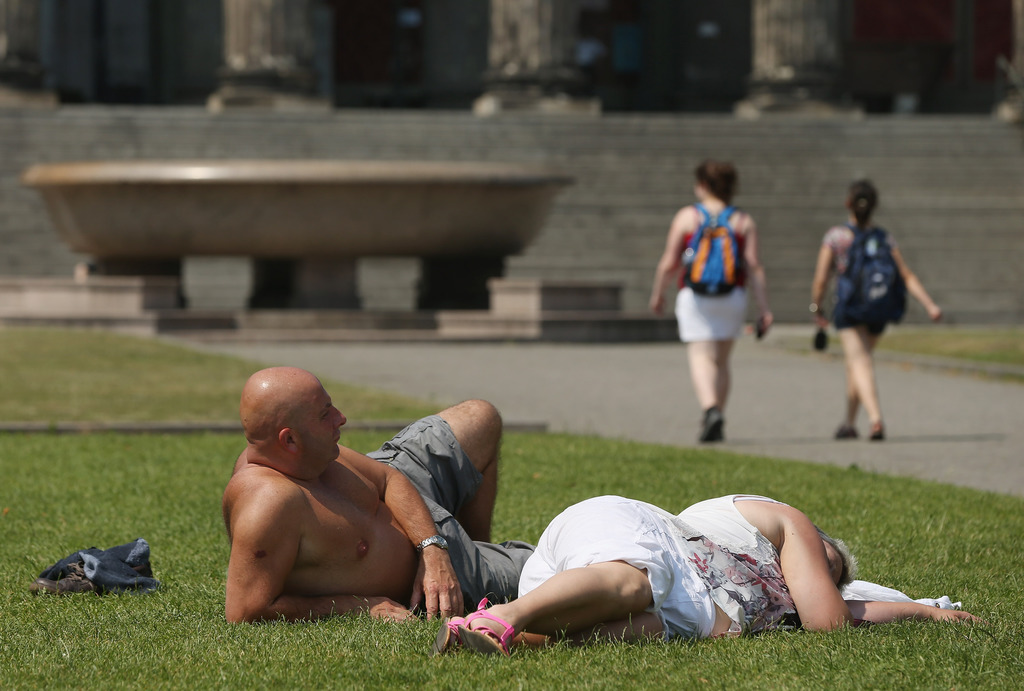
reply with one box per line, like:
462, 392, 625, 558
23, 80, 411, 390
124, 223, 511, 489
519, 495, 795, 638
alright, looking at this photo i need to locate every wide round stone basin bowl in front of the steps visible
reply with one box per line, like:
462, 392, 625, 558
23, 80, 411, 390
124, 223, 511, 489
22, 160, 572, 259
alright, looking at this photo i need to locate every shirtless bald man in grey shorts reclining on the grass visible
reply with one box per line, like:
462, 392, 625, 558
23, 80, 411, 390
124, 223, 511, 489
222, 368, 534, 621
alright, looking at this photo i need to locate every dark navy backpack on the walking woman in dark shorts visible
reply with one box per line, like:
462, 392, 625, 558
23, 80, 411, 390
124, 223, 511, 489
835, 225, 906, 323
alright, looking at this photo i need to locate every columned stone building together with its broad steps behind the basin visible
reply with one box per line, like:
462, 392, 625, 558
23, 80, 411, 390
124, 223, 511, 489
0, 0, 1024, 323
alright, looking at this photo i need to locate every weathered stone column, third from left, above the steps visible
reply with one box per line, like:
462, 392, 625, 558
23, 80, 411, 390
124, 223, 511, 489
473, 0, 600, 115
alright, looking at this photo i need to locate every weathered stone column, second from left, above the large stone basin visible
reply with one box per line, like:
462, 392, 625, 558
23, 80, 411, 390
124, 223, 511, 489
207, 0, 328, 112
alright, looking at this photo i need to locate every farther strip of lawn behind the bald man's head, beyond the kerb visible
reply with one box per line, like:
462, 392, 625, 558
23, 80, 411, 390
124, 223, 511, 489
0, 329, 437, 423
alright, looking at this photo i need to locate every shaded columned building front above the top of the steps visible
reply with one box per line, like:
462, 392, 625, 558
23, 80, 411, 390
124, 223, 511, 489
0, 0, 1024, 114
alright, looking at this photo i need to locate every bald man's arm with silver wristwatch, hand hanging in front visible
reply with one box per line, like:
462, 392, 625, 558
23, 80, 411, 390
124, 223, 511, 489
340, 446, 465, 617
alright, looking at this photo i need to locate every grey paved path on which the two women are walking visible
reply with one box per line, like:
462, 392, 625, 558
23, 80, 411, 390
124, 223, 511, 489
193, 328, 1024, 496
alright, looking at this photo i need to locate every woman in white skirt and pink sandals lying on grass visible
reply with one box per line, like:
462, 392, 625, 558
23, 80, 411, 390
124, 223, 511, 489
433, 494, 978, 655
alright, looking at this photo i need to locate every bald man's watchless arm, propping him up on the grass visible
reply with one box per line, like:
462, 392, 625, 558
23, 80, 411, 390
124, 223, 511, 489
224, 485, 412, 622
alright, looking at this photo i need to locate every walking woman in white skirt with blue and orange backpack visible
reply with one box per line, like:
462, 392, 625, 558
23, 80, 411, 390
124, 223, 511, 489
650, 160, 772, 442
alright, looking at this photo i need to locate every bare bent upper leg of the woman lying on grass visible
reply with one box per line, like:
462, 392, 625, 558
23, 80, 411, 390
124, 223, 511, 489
470, 561, 653, 636
